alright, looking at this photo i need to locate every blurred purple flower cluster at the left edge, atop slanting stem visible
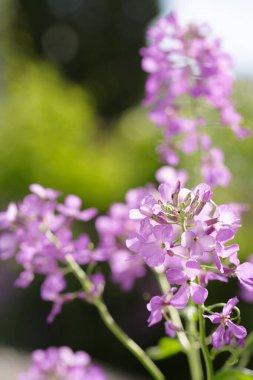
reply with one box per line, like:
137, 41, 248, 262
0, 184, 104, 322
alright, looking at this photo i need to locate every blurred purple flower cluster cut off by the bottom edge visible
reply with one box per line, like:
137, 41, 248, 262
18, 347, 107, 380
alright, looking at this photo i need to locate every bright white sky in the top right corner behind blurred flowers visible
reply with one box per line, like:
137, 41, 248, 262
160, 0, 253, 77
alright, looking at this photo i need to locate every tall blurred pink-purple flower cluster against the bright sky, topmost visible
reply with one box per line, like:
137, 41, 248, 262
141, 13, 248, 186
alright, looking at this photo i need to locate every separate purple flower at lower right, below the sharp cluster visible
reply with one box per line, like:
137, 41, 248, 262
203, 297, 247, 350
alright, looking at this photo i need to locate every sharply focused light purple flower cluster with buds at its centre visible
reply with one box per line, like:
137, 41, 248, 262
127, 182, 253, 347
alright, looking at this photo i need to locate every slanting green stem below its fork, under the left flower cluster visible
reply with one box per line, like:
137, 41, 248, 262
95, 299, 165, 380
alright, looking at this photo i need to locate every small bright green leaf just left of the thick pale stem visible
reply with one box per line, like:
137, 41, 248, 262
147, 337, 182, 360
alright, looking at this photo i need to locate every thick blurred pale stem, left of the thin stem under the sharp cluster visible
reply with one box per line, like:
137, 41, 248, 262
156, 272, 203, 380
